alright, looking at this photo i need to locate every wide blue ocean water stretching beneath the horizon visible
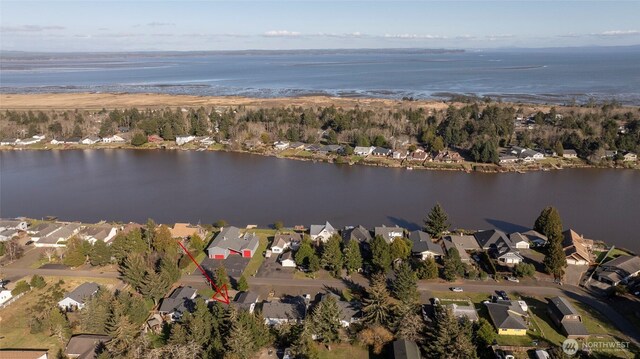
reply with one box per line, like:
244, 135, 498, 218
0, 47, 640, 104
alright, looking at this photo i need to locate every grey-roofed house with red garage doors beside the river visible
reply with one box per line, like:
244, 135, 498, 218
207, 226, 260, 259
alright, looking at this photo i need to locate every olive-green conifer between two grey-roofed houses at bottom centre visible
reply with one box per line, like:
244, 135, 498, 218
311, 294, 342, 343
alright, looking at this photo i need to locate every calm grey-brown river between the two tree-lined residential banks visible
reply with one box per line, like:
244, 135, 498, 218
0, 150, 640, 251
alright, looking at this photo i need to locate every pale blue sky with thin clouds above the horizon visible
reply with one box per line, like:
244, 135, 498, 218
0, 0, 640, 52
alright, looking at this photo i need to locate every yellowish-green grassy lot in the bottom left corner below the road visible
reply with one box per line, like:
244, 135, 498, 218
0, 277, 118, 356
